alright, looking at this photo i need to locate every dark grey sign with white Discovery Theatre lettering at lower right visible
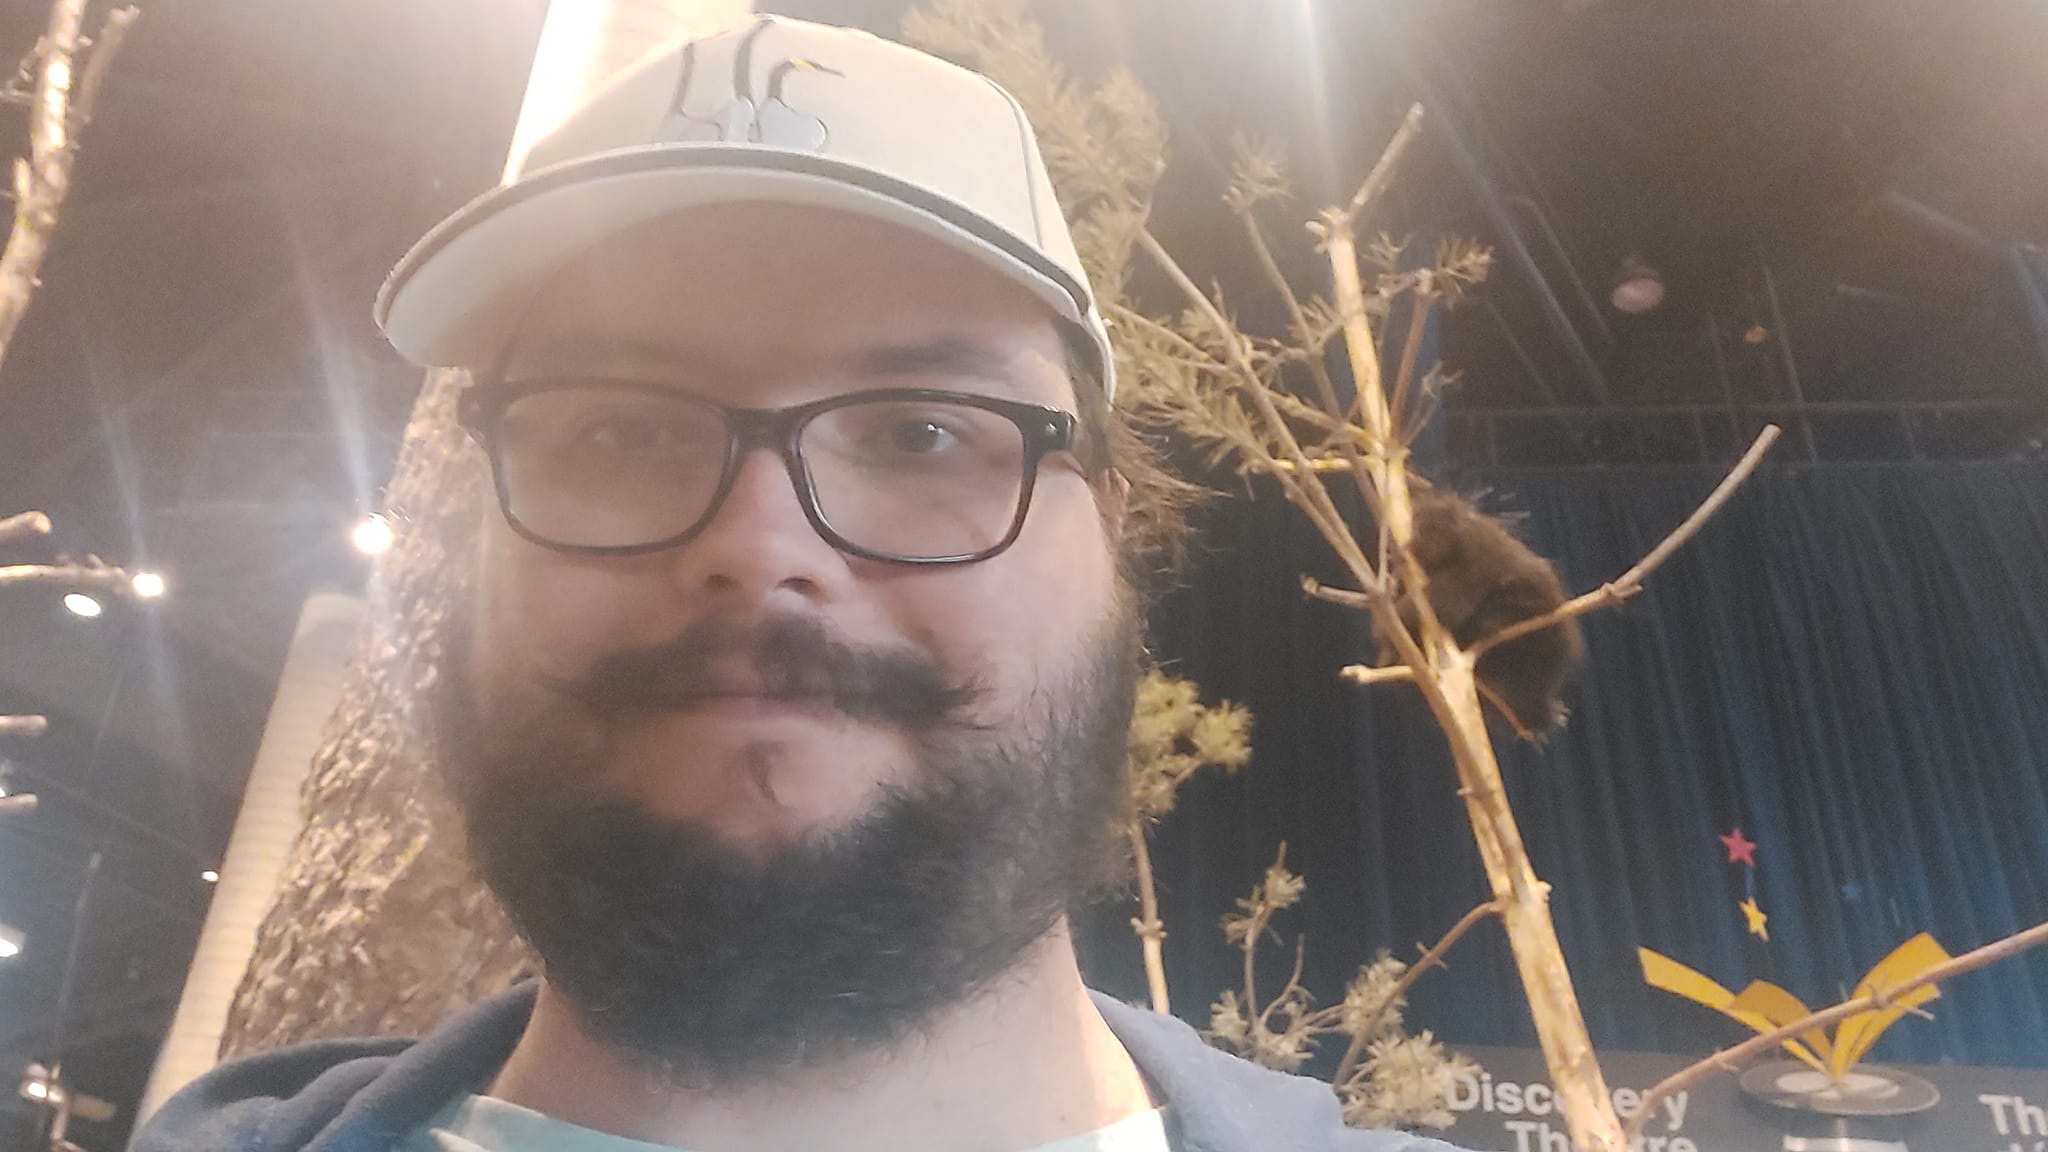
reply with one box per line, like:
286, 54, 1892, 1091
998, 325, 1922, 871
1427, 1047, 2048, 1152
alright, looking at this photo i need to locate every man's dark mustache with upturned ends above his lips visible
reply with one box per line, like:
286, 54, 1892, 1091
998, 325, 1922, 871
555, 617, 979, 728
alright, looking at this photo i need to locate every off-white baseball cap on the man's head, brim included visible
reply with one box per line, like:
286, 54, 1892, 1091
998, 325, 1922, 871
377, 16, 1114, 389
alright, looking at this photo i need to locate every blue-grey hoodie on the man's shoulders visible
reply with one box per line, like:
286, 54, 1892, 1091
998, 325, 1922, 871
129, 982, 1456, 1152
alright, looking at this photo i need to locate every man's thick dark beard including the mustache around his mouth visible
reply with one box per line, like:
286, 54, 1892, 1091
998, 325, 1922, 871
440, 611, 1139, 1084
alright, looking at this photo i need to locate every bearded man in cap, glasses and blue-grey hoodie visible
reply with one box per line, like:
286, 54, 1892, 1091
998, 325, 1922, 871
137, 20, 1444, 1152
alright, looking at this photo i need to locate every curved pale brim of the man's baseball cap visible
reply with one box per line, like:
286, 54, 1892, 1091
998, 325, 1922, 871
377, 143, 1090, 367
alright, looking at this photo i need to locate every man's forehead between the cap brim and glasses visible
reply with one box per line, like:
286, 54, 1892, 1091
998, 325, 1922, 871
489, 205, 1067, 400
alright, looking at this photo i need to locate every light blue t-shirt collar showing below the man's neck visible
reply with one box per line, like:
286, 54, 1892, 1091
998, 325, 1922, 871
393, 1095, 1169, 1152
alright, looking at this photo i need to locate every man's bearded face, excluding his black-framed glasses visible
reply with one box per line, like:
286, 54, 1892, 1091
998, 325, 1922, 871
444, 207, 1135, 1074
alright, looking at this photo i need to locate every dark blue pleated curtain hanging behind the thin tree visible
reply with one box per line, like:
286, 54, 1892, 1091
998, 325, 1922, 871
1083, 463, 2048, 1066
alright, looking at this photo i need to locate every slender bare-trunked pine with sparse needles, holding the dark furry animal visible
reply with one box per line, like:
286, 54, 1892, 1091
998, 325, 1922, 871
905, 0, 1772, 1152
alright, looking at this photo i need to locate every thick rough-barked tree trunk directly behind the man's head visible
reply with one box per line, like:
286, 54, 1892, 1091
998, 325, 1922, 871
221, 0, 752, 1058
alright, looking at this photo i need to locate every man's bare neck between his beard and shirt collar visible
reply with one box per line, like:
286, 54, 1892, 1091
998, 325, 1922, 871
489, 924, 1153, 1152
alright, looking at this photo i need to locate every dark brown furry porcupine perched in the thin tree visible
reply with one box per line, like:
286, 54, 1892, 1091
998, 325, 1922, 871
1380, 488, 1585, 740
